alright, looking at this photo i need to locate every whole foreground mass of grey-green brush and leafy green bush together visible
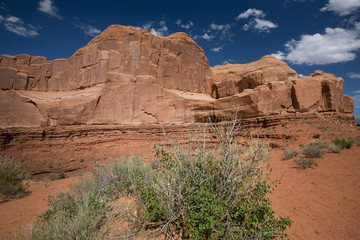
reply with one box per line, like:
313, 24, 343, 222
24, 121, 292, 239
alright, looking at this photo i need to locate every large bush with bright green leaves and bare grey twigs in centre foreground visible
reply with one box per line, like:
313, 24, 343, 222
127, 122, 291, 239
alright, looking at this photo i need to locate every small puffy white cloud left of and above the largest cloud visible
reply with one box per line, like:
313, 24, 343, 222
235, 8, 278, 33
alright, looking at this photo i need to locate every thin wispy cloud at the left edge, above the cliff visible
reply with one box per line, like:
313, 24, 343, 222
0, 15, 40, 37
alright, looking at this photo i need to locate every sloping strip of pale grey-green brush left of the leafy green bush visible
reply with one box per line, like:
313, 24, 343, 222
28, 157, 150, 240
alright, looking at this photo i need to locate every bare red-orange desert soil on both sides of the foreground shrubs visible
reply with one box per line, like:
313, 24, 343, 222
0, 121, 360, 240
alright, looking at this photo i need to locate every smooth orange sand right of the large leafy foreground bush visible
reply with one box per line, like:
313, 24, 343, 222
270, 146, 360, 240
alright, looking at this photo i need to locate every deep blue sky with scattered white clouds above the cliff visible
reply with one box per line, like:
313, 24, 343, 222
0, 0, 360, 119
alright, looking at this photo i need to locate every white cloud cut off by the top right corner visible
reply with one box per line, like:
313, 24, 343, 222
320, 0, 360, 16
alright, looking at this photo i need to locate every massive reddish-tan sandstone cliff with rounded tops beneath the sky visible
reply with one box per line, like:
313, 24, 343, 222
0, 25, 353, 127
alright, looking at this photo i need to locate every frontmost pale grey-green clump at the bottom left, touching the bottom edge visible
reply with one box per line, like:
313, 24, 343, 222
28, 178, 110, 240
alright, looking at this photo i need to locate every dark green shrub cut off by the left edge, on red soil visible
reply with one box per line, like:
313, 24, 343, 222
0, 156, 28, 201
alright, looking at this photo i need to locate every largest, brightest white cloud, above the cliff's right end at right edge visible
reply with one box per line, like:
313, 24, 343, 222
272, 24, 360, 65
